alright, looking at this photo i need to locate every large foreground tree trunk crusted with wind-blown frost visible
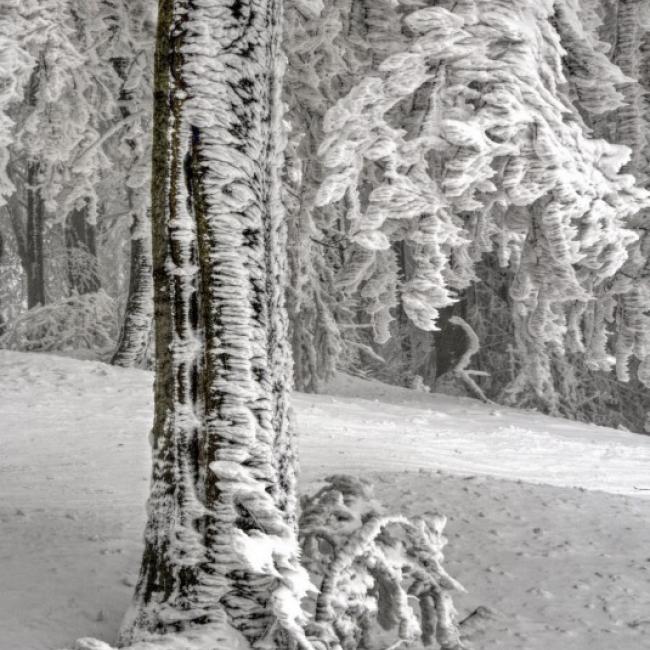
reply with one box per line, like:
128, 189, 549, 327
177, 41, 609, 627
122, 0, 303, 647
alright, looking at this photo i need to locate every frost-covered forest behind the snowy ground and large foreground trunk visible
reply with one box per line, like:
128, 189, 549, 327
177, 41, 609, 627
0, 0, 650, 430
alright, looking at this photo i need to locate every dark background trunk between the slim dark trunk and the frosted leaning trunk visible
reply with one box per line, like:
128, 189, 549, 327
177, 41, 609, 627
65, 203, 100, 296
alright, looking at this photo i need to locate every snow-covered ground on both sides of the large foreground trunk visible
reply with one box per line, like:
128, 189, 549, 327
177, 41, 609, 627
0, 351, 650, 650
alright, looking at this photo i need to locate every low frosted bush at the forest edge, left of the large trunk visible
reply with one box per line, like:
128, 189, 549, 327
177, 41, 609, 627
0, 290, 118, 358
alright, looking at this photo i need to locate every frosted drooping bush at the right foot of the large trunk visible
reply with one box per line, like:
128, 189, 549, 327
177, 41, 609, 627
300, 475, 466, 650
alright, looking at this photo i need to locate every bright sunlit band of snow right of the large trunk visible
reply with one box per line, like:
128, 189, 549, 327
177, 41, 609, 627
294, 376, 650, 496
